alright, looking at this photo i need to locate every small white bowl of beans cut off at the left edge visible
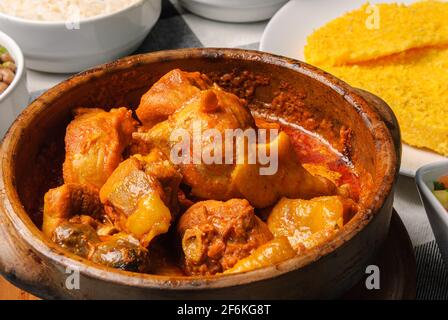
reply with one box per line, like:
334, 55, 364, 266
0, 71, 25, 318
0, 31, 29, 140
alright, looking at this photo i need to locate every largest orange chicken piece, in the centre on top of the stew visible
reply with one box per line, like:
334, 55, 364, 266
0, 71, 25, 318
134, 87, 336, 208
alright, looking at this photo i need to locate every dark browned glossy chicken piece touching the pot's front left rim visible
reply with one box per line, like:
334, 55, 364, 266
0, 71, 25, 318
90, 233, 149, 272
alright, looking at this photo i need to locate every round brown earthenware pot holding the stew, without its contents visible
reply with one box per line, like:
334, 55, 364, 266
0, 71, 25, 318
0, 49, 401, 299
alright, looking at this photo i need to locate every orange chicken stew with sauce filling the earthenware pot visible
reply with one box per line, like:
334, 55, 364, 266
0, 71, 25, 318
37, 69, 361, 276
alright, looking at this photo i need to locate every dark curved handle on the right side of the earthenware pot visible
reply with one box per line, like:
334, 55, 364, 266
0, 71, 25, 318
355, 89, 401, 172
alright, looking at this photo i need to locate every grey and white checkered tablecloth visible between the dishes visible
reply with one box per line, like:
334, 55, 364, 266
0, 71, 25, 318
32, 0, 448, 299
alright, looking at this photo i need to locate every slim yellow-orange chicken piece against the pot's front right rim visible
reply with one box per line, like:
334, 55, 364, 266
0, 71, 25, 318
225, 237, 297, 273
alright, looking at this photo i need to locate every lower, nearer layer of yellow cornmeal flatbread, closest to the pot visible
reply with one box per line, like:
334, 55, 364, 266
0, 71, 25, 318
324, 48, 448, 156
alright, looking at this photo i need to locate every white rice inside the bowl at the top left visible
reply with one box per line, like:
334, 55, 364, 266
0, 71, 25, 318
0, 0, 142, 22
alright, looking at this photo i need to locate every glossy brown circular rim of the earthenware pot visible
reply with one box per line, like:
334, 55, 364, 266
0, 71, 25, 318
0, 48, 398, 290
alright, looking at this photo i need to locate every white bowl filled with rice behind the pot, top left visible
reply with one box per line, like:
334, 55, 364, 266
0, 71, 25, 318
0, 0, 161, 73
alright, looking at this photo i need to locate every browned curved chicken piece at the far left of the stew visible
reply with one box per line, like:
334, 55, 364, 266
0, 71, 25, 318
42, 183, 103, 238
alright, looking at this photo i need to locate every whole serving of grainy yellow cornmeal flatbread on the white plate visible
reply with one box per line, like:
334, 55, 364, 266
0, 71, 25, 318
305, 1, 448, 156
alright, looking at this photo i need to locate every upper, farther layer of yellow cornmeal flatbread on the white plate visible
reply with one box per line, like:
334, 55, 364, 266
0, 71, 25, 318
305, 1, 448, 65
